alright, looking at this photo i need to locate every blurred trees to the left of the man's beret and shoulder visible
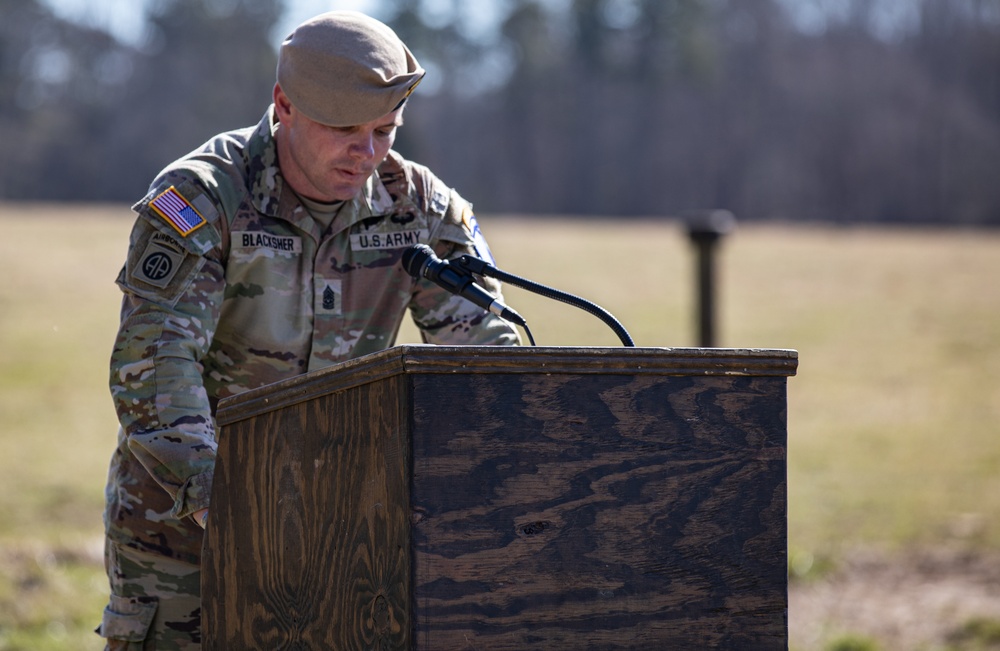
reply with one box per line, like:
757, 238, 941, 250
0, 0, 283, 201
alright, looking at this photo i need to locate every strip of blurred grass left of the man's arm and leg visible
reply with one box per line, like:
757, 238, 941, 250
0, 205, 129, 651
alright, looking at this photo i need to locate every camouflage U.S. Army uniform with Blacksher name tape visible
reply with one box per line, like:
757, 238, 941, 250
99, 107, 519, 650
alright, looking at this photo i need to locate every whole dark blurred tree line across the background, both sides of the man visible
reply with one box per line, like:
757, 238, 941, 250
0, 0, 1000, 225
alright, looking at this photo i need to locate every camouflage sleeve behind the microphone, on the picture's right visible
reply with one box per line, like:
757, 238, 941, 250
410, 182, 521, 346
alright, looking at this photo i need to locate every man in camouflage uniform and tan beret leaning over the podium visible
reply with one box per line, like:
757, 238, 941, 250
98, 12, 519, 651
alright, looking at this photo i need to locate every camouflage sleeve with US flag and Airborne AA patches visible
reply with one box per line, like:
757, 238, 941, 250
110, 179, 225, 518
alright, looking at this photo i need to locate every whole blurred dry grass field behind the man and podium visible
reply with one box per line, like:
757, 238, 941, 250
0, 204, 1000, 651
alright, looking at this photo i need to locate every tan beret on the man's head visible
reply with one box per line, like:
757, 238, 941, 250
278, 11, 424, 127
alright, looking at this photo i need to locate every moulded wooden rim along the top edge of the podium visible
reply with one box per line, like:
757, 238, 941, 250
216, 344, 798, 426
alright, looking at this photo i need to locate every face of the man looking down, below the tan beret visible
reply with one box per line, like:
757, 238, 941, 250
274, 86, 403, 202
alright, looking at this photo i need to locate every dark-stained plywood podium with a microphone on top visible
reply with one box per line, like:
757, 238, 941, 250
202, 346, 798, 651
